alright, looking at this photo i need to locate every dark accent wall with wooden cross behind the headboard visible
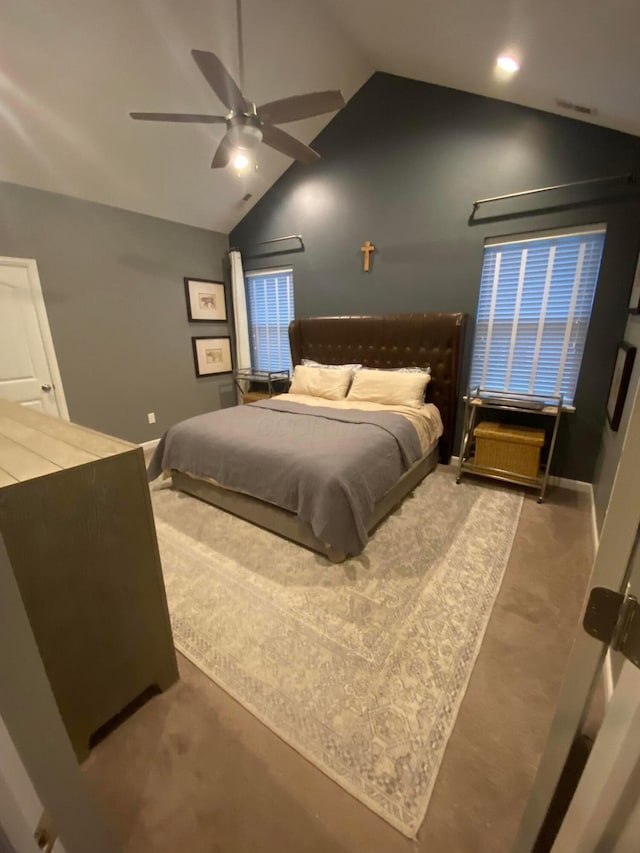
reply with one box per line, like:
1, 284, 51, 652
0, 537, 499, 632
230, 73, 640, 481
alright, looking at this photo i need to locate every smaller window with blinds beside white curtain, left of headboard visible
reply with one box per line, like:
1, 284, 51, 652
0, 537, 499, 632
245, 269, 293, 371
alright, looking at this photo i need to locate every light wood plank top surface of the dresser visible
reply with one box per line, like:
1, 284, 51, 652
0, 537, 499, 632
0, 400, 137, 488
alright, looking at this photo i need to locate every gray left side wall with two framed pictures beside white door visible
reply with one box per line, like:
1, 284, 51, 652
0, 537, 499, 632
0, 183, 234, 442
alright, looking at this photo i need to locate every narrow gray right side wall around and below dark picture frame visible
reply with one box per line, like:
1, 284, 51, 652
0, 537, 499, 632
593, 315, 640, 530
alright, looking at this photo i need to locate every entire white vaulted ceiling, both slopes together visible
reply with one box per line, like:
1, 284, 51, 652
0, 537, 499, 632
0, 0, 640, 232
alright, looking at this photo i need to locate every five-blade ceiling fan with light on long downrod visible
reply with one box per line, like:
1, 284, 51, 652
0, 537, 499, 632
129, 0, 345, 172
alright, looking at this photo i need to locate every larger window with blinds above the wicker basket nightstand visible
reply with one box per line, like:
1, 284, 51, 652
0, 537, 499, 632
470, 225, 606, 406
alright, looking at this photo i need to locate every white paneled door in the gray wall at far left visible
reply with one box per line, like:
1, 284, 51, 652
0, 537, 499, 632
0, 258, 69, 420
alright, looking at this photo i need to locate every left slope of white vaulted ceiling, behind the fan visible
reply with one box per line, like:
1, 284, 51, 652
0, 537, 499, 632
0, 0, 371, 233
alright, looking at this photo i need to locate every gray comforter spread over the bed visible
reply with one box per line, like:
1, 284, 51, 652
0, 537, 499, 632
148, 399, 422, 554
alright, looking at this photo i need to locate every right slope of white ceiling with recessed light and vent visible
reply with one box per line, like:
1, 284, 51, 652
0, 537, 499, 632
324, 0, 640, 135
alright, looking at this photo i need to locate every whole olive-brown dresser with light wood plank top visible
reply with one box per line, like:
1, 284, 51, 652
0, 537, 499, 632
0, 400, 178, 759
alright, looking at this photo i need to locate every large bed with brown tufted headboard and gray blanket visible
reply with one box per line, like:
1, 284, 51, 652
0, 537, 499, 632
149, 313, 465, 562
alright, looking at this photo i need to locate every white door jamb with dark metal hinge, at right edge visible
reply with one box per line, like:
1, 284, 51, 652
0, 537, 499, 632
512, 376, 640, 853
